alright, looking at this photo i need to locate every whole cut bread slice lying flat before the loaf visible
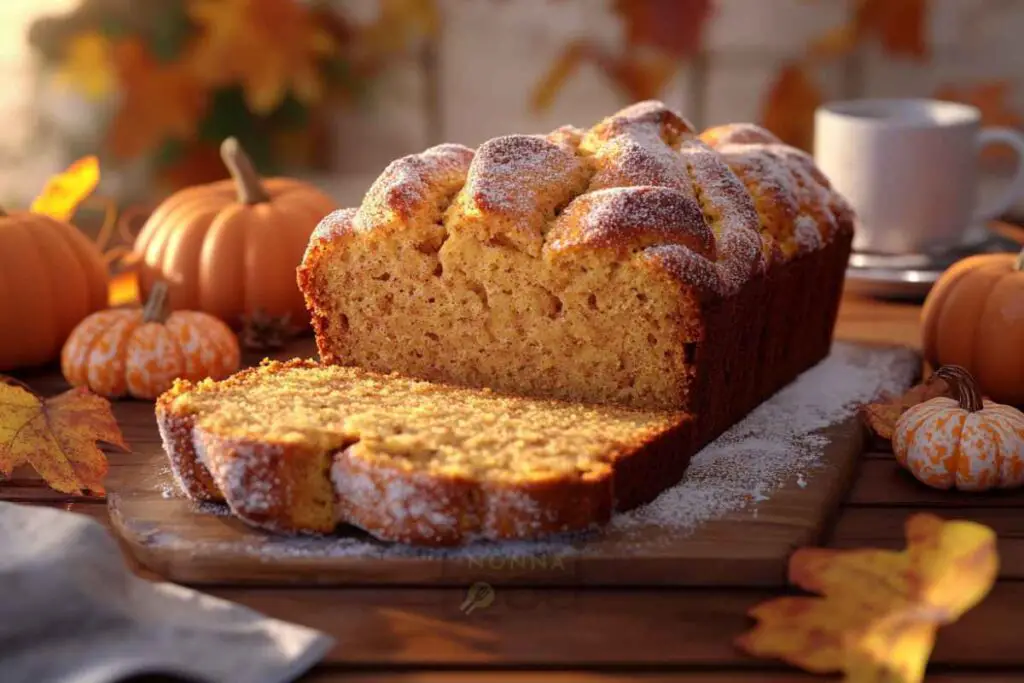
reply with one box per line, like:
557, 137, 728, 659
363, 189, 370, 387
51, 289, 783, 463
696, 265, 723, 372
157, 360, 692, 545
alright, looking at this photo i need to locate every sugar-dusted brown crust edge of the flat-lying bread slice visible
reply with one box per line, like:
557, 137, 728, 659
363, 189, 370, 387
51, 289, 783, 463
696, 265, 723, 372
157, 360, 695, 546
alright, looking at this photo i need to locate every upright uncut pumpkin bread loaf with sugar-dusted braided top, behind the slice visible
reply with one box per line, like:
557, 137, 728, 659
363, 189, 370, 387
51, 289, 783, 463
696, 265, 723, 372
298, 101, 853, 446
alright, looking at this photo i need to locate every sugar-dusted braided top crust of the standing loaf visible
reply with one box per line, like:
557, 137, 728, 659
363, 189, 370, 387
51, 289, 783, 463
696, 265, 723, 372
307, 100, 852, 296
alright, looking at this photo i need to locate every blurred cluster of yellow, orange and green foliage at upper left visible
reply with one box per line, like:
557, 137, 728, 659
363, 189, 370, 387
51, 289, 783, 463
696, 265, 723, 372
30, 0, 438, 188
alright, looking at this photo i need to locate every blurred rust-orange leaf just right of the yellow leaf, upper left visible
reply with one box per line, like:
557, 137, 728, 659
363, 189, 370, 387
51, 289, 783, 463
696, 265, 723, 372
110, 39, 207, 159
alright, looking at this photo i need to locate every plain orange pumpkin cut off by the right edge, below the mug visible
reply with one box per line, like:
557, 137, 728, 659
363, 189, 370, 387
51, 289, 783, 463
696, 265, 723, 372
922, 246, 1024, 405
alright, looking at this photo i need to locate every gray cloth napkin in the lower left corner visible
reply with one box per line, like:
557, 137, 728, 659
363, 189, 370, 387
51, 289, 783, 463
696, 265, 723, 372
0, 503, 334, 683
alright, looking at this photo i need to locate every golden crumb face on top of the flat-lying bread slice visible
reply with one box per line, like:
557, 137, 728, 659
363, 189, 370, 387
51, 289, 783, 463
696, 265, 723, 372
164, 361, 683, 481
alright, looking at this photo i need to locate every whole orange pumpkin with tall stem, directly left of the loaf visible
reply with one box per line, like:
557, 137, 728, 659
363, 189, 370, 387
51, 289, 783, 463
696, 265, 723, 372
134, 138, 337, 328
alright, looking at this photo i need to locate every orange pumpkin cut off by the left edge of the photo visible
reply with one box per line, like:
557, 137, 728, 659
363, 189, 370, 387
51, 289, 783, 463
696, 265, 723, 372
0, 210, 108, 372
